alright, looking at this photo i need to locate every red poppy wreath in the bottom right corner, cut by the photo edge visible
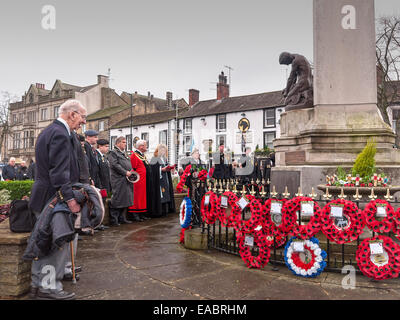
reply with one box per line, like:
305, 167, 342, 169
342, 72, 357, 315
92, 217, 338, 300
356, 235, 400, 280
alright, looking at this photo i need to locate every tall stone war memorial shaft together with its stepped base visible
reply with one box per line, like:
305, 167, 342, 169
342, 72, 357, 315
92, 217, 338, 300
271, 0, 400, 195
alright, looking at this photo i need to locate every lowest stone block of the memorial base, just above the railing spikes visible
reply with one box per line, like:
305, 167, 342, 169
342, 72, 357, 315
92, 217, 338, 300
271, 166, 400, 197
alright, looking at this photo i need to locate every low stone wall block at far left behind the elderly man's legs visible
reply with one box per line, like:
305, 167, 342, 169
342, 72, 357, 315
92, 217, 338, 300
0, 219, 31, 298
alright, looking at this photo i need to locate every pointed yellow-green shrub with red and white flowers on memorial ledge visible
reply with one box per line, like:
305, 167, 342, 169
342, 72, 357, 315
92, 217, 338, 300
326, 140, 389, 188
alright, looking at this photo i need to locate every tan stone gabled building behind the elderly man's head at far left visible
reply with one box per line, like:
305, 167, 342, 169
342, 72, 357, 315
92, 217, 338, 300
8, 75, 124, 161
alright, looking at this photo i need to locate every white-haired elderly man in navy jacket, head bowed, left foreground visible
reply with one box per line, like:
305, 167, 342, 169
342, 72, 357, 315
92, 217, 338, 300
29, 100, 87, 300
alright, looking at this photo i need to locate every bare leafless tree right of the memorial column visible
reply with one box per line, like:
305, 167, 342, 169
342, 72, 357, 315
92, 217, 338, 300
376, 17, 400, 125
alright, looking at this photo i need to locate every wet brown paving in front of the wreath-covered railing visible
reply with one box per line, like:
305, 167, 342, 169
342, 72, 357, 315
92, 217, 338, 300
23, 214, 400, 300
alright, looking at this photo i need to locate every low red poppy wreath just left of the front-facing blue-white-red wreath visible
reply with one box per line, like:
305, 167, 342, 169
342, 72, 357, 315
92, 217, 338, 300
236, 230, 271, 269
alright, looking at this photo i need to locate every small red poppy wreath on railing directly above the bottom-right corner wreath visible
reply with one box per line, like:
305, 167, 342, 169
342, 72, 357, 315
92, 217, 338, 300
363, 199, 395, 233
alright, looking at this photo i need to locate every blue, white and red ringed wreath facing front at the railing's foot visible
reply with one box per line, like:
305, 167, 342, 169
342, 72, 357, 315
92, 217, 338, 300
285, 237, 327, 278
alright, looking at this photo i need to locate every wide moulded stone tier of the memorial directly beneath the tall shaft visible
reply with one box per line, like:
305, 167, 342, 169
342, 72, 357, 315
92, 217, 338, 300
274, 105, 400, 167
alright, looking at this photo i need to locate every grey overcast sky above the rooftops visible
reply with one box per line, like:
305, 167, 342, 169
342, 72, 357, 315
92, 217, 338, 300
0, 0, 400, 101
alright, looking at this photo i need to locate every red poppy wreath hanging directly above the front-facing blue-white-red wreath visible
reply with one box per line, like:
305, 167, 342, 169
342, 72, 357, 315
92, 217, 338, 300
282, 197, 321, 240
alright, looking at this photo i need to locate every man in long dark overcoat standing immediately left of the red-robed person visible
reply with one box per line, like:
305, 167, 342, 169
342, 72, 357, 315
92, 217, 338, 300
107, 136, 133, 226
